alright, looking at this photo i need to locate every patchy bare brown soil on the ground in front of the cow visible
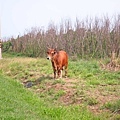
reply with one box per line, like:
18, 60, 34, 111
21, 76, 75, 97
26, 77, 120, 114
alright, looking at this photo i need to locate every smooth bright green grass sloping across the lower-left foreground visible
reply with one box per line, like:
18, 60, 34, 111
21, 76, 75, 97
0, 74, 100, 120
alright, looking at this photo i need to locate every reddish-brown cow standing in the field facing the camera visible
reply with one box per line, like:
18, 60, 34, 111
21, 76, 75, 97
47, 48, 68, 78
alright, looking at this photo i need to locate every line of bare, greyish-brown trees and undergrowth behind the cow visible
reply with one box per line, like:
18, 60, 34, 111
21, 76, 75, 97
3, 15, 120, 59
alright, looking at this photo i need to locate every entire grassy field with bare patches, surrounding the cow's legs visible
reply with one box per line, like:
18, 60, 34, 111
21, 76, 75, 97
0, 54, 120, 120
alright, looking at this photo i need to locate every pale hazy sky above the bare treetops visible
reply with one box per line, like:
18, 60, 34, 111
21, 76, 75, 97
0, 0, 120, 38
